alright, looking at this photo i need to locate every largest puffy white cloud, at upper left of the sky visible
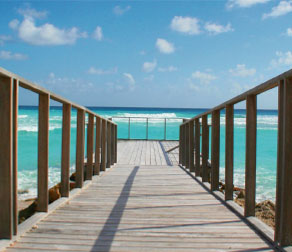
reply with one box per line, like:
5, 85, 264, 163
13, 18, 87, 45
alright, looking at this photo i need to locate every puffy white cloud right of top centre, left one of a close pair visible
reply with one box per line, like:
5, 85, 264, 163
170, 16, 201, 35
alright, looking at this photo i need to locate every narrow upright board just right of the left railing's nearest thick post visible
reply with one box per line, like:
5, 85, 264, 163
12, 79, 19, 235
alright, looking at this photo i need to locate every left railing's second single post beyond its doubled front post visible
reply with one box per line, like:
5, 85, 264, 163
60, 103, 71, 197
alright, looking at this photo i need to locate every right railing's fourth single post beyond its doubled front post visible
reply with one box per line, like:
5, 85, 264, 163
202, 115, 209, 182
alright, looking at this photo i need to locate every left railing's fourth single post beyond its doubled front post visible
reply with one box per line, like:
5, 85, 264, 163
86, 114, 94, 180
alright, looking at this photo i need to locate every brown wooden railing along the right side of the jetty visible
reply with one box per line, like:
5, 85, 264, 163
179, 70, 292, 246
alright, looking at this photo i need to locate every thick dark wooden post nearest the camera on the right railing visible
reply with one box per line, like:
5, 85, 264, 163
276, 78, 292, 246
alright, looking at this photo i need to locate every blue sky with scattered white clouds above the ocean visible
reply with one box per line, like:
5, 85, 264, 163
0, 0, 292, 108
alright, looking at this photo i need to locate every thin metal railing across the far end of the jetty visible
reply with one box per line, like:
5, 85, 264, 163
111, 116, 185, 140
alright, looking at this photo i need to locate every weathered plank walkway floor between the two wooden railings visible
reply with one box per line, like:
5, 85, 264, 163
7, 141, 273, 252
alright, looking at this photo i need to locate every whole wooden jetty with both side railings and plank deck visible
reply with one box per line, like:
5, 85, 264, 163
0, 69, 292, 252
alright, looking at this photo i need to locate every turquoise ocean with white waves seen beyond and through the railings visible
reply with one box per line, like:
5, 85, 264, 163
18, 106, 278, 201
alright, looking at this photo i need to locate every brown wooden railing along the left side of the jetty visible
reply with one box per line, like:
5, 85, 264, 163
0, 68, 117, 239
